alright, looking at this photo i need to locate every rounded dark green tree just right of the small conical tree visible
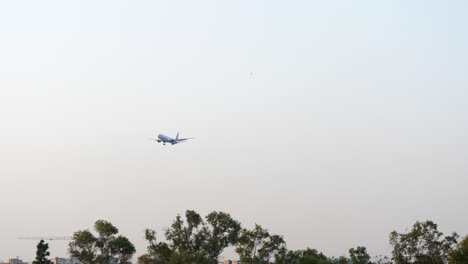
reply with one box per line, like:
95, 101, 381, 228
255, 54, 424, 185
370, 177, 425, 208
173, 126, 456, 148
68, 220, 135, 264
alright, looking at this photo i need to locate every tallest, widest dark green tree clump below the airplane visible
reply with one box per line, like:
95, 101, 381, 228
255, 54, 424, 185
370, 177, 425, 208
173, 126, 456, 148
138, 210, 241, 264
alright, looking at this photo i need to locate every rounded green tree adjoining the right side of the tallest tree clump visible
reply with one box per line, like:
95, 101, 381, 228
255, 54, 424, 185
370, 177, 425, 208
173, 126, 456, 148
236, 225, 286, 264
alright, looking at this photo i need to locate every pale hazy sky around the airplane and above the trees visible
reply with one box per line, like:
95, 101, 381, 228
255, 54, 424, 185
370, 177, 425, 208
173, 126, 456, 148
0, 0, 468, 260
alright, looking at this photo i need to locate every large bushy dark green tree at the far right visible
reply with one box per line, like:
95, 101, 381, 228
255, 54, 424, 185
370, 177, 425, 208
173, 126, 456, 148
390, 221, 458, 264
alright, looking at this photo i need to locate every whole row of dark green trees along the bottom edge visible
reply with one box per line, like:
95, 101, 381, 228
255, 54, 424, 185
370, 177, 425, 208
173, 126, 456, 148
33, 210, 468, 264
